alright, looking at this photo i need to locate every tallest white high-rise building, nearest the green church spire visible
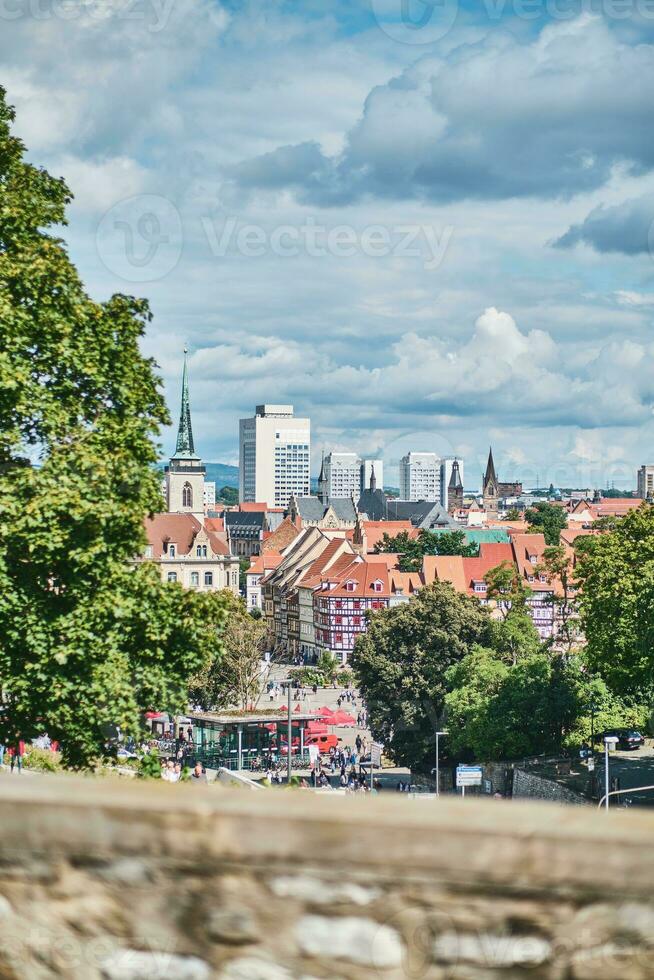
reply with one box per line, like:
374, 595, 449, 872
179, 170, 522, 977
239, 405, 311, 507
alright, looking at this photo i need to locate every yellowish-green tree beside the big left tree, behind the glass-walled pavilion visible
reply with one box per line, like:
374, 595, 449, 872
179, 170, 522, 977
189, 593, 268, 711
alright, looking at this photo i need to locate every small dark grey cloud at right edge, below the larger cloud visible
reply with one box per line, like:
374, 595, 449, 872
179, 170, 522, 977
554, 194, 654, 255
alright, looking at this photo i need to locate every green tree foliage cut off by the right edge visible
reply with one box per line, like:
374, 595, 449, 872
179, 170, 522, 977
575, 504, 654, 699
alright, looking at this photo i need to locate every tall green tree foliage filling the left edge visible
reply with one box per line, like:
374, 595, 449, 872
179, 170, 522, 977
0, 90, 231, 766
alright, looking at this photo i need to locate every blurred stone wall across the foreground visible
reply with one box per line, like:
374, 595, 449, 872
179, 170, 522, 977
0, 775, 654, 980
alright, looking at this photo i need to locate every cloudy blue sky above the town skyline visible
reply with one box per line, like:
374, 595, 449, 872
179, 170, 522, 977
5, 0, 654, 488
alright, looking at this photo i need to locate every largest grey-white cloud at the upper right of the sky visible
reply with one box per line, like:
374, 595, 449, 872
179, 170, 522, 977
231, 15, 654, 206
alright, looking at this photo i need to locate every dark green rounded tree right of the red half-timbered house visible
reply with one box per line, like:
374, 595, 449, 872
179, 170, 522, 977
351, 582, 492, 767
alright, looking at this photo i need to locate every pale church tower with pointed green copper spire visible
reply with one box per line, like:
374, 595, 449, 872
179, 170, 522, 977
166, 348, 206, 521
